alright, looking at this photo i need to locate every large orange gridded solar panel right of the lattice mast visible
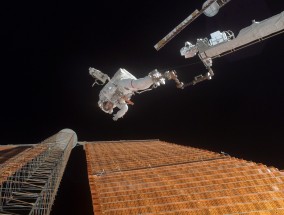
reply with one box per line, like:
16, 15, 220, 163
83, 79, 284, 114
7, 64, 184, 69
85, 141, 284, 215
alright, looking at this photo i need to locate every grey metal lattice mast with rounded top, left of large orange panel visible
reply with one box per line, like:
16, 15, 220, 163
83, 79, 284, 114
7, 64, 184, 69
0, 129, 77, 215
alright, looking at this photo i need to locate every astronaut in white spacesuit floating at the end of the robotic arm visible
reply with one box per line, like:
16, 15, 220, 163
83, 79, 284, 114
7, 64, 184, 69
89, 67, 169, 121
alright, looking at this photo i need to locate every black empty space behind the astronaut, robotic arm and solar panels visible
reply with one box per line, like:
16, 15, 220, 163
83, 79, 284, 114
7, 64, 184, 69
0, 0, 284, 214
